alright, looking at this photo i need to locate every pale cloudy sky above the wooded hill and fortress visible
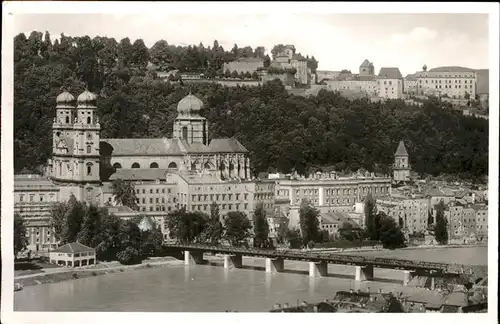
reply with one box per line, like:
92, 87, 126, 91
14, 12, 489, 75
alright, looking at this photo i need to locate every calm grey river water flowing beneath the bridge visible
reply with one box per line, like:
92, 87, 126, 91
14, 247, 487, 312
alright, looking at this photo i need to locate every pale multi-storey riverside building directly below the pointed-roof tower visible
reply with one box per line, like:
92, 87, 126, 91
377, 197, 429, 233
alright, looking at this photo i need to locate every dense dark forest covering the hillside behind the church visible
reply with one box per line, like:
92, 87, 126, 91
14, 32, 488, 185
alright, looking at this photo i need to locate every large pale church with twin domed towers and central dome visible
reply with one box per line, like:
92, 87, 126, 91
47, 90, 251, 202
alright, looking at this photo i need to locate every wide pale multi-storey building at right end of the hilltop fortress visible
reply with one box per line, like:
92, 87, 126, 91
415, 65, 477, 99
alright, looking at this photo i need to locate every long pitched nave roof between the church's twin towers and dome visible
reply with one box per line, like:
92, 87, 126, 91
101, 138, 182, 156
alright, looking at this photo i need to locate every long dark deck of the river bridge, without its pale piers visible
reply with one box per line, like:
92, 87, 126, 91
165, 244, 480, 274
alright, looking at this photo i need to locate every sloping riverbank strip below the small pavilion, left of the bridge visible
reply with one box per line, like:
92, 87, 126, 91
14, 257, 183, 287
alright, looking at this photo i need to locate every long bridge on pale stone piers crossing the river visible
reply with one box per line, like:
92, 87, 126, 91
166, 244, 486, 285
